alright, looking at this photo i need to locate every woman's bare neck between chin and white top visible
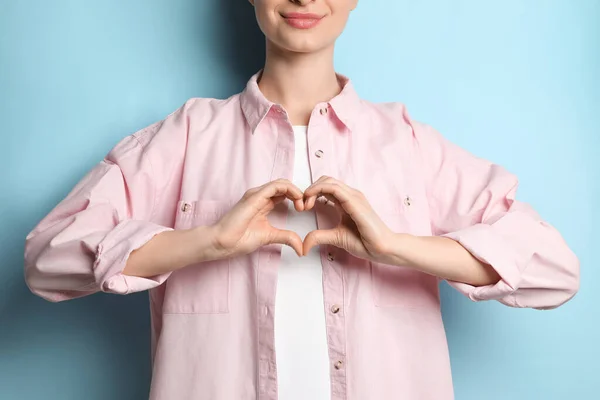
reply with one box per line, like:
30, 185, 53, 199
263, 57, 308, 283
258, 42, 341, 125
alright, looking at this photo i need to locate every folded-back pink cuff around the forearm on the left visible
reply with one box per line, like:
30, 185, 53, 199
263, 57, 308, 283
94, 220, 173, 294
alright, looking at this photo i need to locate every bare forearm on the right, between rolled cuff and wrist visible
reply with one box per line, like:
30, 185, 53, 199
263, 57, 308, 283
385, 233, 500, 286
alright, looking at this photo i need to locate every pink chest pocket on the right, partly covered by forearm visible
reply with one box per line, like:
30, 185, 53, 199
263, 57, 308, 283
369, 196, 440, 311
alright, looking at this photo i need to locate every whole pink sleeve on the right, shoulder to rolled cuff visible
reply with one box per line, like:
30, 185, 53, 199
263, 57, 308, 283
412, 122, 579, 309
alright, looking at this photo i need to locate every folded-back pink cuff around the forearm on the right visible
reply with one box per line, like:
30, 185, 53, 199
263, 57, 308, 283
442, 224, 521, 307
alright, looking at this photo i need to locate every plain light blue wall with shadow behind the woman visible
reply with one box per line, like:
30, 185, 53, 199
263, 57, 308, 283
0, 0, 600, 400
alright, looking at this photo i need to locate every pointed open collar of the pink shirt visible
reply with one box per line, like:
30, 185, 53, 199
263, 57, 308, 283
240, 70, 361, 134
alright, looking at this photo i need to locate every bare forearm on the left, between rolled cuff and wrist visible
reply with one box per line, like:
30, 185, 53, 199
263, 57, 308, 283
123, 226, 217, 277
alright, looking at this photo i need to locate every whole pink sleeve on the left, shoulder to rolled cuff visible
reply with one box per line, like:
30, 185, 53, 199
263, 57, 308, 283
25, 104, 185, 302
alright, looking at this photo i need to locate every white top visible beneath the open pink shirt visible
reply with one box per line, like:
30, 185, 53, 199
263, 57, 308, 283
275, 126, 331, 400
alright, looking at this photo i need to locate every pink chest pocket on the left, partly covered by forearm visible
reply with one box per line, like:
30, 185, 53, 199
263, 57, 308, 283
163, 200, 230, 314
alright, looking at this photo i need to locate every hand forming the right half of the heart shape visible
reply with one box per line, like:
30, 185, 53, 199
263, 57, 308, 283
303, 176, 396, 261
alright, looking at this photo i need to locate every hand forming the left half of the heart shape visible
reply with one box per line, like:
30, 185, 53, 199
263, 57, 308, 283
213, 179, 304, 258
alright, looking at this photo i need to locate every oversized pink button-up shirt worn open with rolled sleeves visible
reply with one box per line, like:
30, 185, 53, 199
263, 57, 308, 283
25, 75, 579, 400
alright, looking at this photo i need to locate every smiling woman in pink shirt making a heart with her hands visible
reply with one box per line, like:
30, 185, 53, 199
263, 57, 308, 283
25, 0, 579, 400
